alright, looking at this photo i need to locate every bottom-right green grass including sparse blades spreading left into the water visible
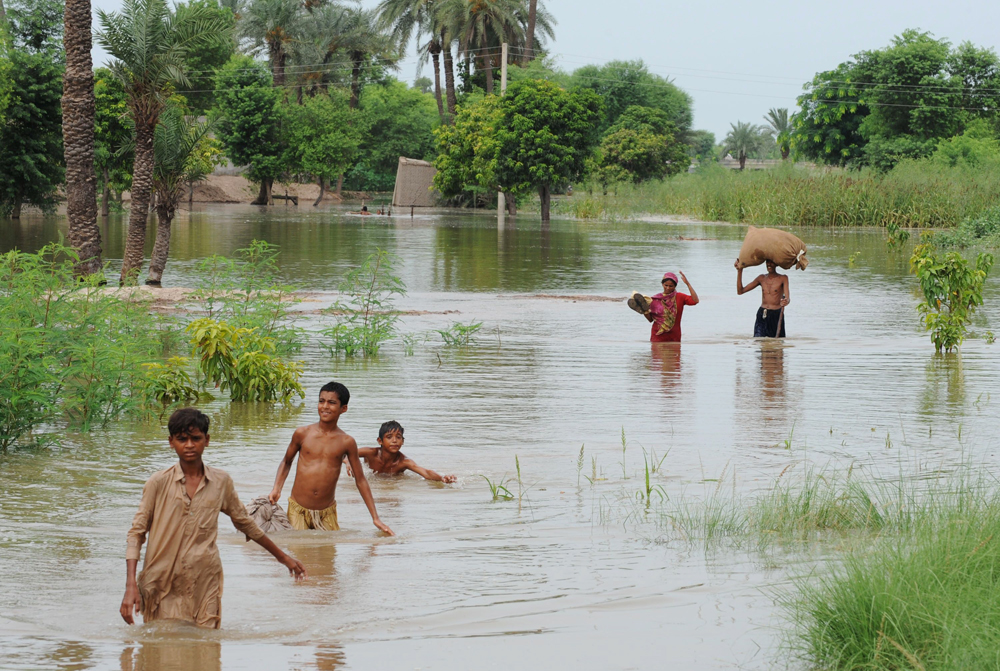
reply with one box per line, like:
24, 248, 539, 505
640, 469, 1000, 671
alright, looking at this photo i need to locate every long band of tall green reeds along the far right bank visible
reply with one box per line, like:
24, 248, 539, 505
555, 162, 1000, 228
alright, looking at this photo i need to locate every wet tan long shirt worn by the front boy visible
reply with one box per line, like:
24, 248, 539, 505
125, 463, 264, 629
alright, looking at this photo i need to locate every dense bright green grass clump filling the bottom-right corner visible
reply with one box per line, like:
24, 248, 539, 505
785, 479, 1000, 671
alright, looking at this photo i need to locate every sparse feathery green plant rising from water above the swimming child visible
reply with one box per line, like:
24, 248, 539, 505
321, 249, 406, 357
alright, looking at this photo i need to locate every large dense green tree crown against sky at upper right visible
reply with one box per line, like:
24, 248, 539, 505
791, 30, 1000, 171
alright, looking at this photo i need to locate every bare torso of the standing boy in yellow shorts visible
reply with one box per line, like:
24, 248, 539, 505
292, 424, 353, 510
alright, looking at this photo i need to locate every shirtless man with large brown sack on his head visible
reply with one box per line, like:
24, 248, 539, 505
734, 226, 809, 338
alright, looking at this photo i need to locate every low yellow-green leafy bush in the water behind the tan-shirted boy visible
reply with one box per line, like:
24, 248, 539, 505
187, 318, 305, 403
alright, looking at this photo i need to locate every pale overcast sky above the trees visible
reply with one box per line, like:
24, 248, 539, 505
92, 0, 1000, 139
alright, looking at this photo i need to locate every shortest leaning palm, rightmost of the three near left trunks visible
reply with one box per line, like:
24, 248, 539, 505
146, 107, 213, 286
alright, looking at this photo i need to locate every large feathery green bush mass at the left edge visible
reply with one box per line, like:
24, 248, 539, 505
0, 244, 162, 449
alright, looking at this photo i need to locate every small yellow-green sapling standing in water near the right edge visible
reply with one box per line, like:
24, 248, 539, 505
910, 238, 993, 352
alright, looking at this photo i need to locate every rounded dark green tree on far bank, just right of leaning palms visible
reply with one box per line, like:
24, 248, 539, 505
215, 55, 285, 205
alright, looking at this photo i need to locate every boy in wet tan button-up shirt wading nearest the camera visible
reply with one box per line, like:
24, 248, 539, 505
119, 408, 306, 629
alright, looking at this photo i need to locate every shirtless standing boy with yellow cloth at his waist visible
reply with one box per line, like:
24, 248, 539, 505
267, 382, 394, 536
